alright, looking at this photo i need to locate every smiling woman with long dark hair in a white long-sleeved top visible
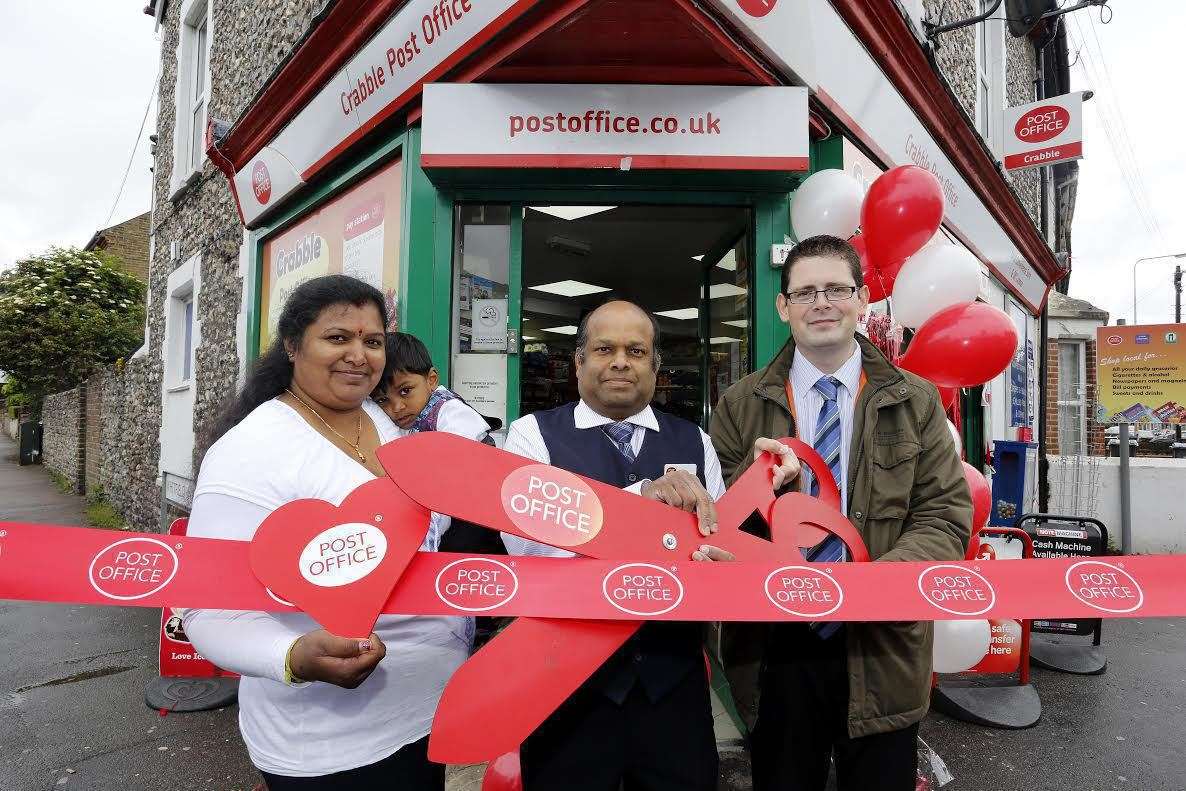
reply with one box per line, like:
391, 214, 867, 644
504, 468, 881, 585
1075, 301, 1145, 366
184, 275, 472, 791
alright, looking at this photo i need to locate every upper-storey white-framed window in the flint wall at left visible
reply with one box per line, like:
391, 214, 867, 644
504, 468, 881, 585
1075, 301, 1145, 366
172, 0, 210, 193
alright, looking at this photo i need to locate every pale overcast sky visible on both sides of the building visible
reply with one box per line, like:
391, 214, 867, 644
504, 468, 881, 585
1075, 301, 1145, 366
0, 0, 1186, 323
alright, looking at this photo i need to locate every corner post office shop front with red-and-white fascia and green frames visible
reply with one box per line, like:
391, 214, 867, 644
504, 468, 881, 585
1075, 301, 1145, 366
210, 0, 1065, 439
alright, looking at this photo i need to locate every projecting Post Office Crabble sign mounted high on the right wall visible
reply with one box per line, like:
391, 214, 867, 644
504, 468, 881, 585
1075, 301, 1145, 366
1005, 93, 1083, 171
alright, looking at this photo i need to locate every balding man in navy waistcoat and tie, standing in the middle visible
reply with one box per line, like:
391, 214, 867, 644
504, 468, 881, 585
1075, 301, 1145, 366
503, 301, 768, 791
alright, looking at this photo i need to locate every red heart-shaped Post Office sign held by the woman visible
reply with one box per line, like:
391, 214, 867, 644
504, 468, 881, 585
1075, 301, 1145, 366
250, 478, 431, 637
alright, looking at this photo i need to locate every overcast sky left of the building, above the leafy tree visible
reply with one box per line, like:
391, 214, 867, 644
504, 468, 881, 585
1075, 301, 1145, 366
0, 0, 160, 268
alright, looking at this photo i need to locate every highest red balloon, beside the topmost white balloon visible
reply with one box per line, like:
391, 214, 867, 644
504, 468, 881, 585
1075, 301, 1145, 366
861, 165, 943, 278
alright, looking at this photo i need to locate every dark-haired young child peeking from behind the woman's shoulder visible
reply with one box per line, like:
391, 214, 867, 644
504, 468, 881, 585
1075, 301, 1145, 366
375, 332, 502, 445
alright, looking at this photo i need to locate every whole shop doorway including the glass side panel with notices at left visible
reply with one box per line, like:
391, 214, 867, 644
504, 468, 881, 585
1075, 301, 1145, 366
452, 204, 753, 427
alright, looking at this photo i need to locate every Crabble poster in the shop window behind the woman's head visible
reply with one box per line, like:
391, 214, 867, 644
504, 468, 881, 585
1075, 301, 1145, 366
257, 160, 403, 350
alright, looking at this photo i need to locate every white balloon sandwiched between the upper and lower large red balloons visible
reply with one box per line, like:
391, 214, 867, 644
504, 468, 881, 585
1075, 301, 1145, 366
893, 244, 980, 330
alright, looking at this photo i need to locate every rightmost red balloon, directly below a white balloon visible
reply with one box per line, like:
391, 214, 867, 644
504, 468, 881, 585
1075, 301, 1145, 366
898, 302, 1018, 388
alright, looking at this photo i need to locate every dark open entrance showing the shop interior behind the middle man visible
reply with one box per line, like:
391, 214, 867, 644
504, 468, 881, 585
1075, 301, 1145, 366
517, 205, 752, 426
